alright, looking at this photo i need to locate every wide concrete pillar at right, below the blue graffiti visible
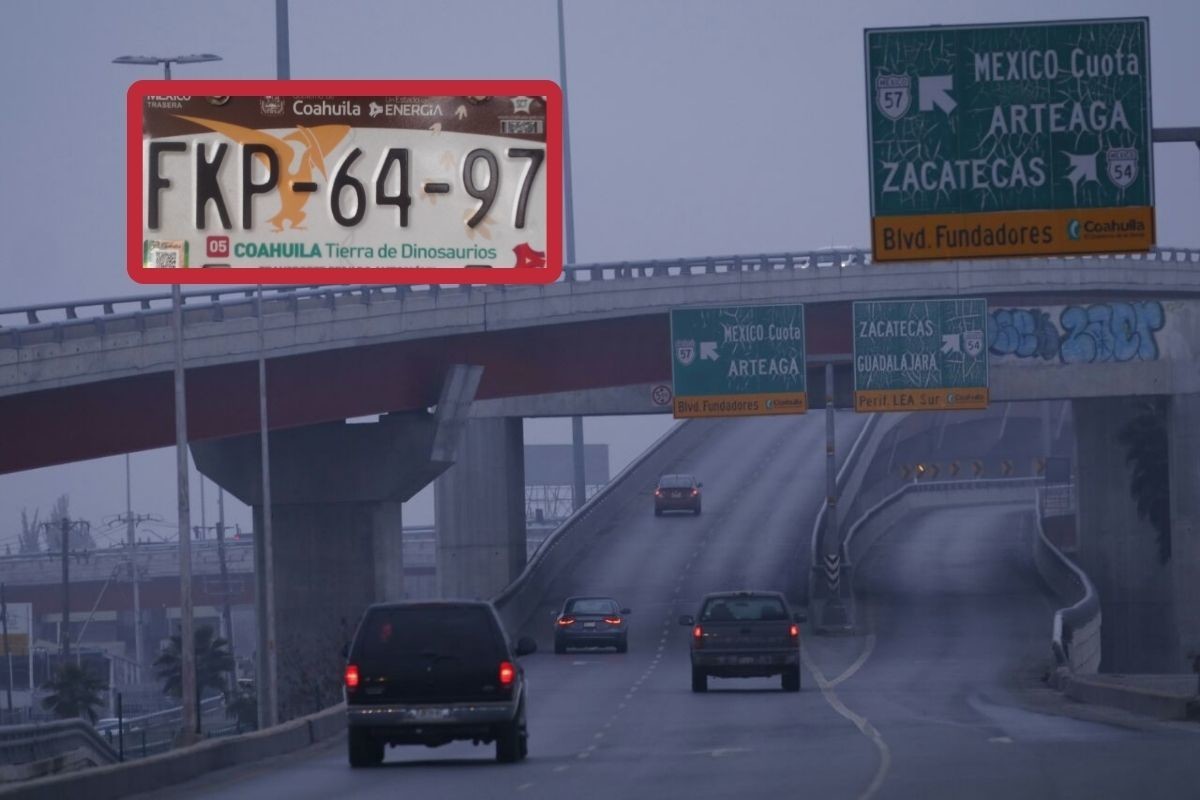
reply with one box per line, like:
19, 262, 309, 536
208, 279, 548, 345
1072, 397, 1178, 673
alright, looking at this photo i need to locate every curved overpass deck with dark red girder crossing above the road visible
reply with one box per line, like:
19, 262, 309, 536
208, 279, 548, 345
0, 248, 1200, 474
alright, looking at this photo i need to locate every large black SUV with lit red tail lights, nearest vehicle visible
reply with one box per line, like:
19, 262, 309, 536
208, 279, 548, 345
346, 601, 538, 766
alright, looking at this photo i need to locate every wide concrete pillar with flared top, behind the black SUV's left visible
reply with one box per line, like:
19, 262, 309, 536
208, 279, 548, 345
192, 411, 449, 721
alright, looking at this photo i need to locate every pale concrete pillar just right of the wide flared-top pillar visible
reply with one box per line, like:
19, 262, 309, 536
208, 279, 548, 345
433, 417, 523, 599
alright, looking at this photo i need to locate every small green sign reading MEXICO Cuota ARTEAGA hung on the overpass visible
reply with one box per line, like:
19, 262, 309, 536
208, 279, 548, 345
671, 305, 808, 419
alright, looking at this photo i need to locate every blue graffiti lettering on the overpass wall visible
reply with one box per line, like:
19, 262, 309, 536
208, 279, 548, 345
988, 300, 1166, 363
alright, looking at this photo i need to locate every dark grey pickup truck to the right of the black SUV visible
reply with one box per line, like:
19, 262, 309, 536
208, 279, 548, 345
679, 591, 805, 692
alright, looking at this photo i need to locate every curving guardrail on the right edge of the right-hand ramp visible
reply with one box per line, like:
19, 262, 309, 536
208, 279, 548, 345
1033, 488, 1100, 673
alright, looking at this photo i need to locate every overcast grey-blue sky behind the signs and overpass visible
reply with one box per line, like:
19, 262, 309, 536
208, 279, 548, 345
0, 0, 1200, 544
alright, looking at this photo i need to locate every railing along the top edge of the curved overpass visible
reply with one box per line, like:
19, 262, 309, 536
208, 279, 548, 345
0, 247, 1200, 337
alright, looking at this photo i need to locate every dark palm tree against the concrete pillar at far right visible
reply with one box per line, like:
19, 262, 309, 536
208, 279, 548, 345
1117, 397, 1171, 564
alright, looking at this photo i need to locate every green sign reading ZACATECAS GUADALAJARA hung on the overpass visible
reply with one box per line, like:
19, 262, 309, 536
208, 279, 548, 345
854, 299, 988, 411
